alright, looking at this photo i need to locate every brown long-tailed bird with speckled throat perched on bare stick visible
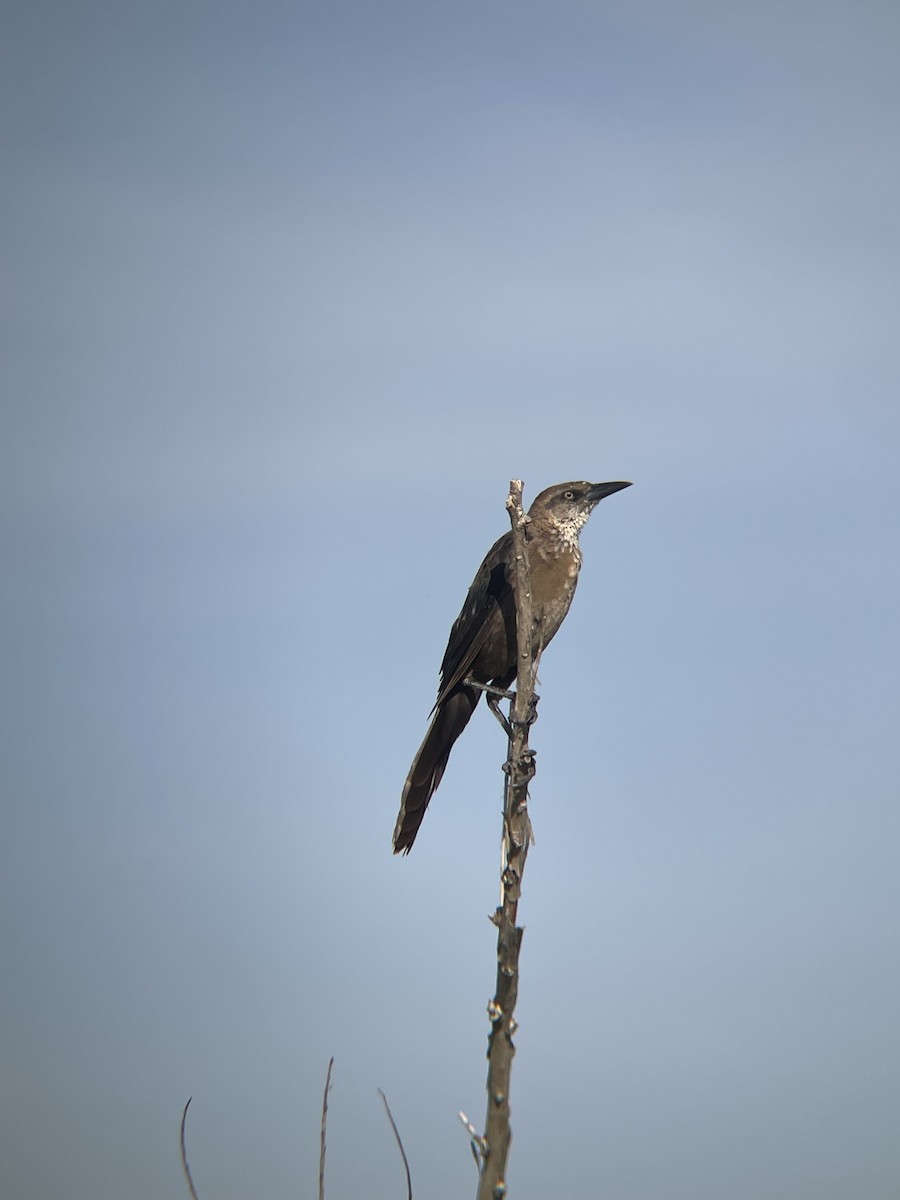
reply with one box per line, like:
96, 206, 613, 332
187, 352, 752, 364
394, 480, 631, 854
